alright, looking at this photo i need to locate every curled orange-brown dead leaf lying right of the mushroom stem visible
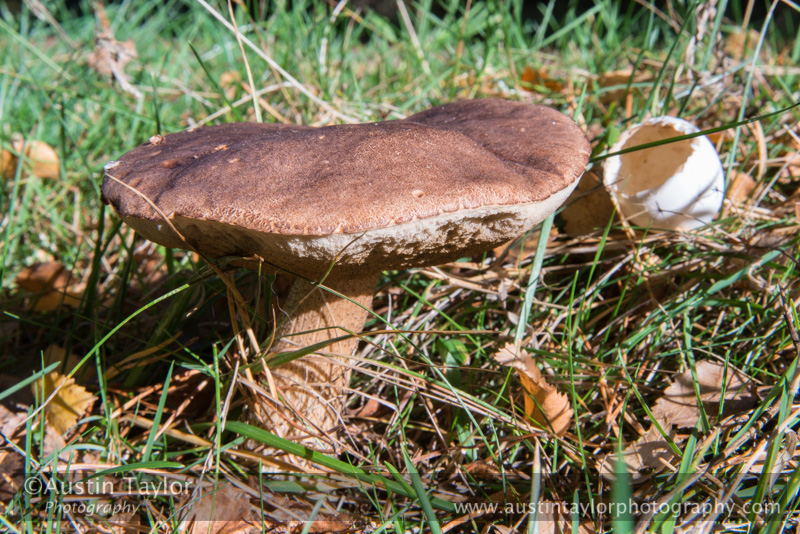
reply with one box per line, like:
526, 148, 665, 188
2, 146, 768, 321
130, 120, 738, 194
494, 343, 573, 436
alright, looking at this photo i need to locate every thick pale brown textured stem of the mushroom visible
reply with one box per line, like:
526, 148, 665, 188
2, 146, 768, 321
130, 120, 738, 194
264, 273, 378, 441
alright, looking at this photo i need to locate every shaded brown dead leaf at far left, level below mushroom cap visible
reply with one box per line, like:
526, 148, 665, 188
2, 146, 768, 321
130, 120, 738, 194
16, 261, 83, 311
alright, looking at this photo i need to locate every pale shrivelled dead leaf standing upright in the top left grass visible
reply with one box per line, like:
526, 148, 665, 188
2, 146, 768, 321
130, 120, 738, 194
86, 2, 142, 98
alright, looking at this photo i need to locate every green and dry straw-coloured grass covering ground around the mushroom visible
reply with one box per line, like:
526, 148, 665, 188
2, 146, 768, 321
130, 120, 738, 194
0, 0, 800, 533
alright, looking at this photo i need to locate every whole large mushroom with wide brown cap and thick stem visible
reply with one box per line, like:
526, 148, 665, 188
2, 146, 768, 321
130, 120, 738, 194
102, 99, 590, 443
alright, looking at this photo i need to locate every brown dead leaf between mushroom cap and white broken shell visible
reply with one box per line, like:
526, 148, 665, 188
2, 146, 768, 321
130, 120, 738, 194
561, 172, 614, 237
